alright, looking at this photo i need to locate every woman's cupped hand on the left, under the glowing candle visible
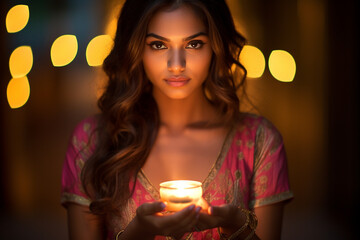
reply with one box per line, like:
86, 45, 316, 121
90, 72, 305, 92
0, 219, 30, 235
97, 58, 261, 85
121, 202, 201, 239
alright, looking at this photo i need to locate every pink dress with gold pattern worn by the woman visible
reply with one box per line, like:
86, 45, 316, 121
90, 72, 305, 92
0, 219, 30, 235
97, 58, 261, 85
61, 114, 293, 239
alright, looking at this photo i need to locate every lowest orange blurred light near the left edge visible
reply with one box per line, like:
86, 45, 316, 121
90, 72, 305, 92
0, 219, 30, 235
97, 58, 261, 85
6, 76, 30, 108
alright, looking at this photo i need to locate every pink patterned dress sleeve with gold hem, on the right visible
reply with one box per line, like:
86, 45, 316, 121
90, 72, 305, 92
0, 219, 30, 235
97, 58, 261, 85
249, 119, 293, 208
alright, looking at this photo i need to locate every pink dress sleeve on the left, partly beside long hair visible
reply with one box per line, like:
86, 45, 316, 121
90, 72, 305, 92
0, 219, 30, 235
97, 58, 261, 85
61, 119, 97, 207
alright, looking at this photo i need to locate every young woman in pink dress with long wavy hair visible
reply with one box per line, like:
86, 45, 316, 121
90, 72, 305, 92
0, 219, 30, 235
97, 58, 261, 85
62, 0, 292, 240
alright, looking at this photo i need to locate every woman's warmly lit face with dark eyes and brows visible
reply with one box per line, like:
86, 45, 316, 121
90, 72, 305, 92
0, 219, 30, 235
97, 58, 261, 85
143, 6, 212, 99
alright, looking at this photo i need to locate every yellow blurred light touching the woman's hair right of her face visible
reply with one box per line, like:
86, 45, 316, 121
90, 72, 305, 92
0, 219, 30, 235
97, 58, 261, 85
240, 45, 265, 78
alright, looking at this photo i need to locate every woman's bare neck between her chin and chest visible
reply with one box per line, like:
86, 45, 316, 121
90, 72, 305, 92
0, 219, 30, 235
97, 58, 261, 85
154, 90, 216, 134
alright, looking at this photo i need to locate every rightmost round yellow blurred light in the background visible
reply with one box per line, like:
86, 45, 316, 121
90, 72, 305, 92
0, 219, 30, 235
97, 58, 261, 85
269, 50, 296, 82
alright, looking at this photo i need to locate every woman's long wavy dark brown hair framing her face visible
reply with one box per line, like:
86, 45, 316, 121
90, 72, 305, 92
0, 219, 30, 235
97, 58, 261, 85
82, 0, 246, 215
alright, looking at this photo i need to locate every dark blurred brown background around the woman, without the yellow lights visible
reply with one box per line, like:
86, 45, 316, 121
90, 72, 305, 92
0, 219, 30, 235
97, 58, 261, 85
0, 0, 360, 240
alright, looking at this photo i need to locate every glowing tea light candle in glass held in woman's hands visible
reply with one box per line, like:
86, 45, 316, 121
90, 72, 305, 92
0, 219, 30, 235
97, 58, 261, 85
160, 180, 202, 212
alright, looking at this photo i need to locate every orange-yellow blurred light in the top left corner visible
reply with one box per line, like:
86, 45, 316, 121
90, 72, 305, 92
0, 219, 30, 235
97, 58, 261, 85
6, 5, 30, 33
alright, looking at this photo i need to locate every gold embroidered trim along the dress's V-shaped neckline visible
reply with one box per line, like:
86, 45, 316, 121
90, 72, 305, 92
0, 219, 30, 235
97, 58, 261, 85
137, 124, 237, 200
